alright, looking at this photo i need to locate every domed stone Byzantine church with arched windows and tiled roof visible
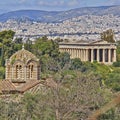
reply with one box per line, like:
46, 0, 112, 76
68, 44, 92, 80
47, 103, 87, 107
0, 46, 47, 94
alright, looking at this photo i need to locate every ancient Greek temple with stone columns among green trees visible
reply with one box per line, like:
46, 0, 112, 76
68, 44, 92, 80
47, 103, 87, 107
59, 40, 116, 64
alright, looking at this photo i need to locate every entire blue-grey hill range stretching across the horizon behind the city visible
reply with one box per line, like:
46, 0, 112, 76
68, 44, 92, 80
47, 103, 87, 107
0, 6, 120, 22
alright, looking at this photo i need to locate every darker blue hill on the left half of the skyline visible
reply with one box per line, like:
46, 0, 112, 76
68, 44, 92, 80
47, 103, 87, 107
0, 10, 59, 22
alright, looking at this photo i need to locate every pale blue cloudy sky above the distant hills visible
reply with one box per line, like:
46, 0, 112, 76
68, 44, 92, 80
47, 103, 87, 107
0, 0, 120, 12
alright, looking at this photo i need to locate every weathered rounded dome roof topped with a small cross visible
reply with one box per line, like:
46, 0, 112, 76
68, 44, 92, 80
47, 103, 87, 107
9, 47, 39, 64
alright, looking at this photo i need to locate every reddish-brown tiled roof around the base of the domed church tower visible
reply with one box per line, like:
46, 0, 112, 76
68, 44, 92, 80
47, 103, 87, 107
0, 78, 57, 94
